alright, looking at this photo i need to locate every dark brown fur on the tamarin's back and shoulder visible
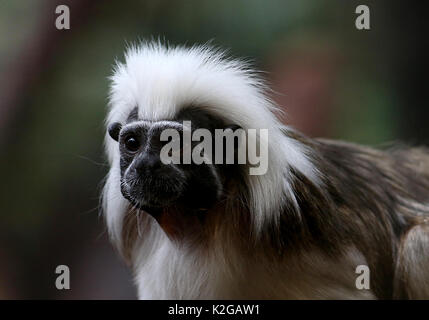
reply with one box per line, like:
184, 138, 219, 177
274, 133, 429, 299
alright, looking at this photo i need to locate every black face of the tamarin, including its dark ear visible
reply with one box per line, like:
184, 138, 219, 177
109, 110, 238, 216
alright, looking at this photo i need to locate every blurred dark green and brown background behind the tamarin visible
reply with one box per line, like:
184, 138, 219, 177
0, 0, 429, 299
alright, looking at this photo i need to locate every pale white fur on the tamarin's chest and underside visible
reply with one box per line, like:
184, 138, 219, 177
134, 226, 375, 299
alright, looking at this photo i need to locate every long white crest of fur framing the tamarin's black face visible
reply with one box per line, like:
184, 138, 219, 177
104, 42, 318, 248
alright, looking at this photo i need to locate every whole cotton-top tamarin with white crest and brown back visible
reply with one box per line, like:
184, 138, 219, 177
103, 42, 429, 299
